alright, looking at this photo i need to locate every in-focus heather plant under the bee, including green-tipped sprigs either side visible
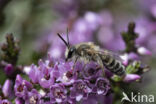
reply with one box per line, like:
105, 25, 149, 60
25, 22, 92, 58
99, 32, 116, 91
0, 23, 151, 104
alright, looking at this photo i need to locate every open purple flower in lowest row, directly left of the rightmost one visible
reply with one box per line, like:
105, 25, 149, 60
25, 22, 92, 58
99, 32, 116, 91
70, 80, 91, 101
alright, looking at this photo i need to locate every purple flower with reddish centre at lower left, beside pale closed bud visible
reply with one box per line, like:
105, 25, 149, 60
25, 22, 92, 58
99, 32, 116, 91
14, 75, 33, 99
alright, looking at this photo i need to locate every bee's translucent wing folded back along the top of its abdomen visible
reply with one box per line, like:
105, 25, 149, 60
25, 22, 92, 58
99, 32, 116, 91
99, 49, 123, 62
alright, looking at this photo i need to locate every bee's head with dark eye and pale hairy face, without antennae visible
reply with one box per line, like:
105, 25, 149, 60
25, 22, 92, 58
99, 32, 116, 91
65, 46, 76, 61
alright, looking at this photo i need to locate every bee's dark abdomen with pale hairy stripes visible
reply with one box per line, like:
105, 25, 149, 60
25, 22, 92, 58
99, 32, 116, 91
101, 55, 125, 76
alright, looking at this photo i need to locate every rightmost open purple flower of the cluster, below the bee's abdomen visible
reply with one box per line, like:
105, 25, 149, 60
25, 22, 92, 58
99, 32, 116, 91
93, 77, 110, 95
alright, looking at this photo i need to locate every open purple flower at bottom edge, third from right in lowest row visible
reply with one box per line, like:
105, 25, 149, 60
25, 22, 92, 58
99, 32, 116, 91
49, 84, 67, 103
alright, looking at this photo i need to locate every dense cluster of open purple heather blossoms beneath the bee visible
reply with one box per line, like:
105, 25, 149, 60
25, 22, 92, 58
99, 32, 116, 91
21, 58, 111, 104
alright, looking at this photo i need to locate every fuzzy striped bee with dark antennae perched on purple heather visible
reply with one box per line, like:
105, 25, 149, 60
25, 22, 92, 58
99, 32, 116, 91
57, 32, 126, 77
